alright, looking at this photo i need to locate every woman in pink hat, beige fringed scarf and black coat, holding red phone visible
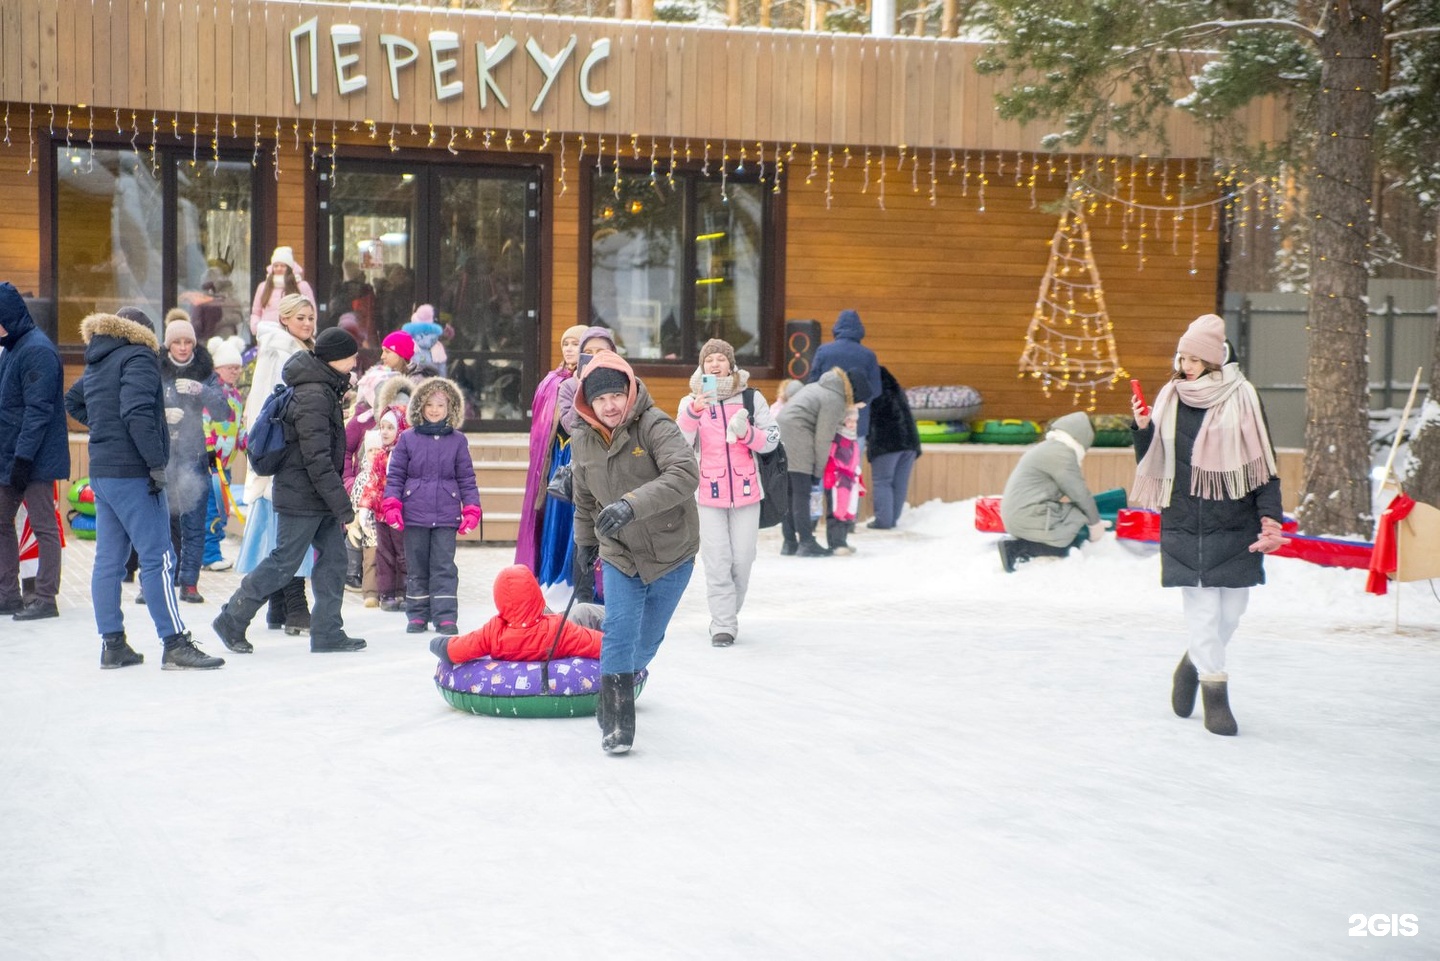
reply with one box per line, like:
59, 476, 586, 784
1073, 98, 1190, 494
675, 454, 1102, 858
1130, 314, 1284, 735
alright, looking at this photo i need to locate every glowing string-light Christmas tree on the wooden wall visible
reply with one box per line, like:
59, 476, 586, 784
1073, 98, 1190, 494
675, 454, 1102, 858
1020, 186, 1129, 411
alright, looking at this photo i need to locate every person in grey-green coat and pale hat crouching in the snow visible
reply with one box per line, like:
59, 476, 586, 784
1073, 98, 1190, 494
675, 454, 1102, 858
999, 411, 1104, 573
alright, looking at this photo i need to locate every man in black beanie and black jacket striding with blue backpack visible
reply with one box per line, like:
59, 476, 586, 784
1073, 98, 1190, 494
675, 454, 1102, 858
215, 327, 366, 654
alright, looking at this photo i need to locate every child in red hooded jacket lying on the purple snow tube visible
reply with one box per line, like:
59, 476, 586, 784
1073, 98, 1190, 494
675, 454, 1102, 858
431, 563, 605, 664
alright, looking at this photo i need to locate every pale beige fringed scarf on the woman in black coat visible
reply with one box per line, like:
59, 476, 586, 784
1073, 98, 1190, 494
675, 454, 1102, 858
1130, 363, 1276, 510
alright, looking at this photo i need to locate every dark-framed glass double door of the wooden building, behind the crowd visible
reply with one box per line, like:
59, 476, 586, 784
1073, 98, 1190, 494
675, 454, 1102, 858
315, 157, 541, 431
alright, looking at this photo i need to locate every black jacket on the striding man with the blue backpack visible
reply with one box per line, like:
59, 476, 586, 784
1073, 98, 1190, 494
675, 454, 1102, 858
271, 350, 356, 524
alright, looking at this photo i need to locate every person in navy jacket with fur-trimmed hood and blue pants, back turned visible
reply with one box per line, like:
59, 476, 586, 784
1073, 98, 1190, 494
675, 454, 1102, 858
65, 307, 225, 670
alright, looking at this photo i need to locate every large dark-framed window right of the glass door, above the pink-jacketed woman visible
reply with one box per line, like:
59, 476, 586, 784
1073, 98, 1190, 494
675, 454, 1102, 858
590, 169, 775, 367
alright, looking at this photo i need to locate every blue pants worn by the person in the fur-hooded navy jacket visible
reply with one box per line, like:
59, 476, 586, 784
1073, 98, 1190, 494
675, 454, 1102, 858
91, 477, 184, 640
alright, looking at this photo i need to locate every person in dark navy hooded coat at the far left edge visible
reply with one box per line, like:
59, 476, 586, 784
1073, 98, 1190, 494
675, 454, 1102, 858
0, 284, 71, 621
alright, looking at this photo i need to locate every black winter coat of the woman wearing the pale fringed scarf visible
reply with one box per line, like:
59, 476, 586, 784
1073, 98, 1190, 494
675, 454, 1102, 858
1135, 402, 1283, 588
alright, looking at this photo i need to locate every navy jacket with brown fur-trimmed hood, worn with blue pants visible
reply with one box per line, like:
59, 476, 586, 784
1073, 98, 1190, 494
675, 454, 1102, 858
65, 314, 170, 477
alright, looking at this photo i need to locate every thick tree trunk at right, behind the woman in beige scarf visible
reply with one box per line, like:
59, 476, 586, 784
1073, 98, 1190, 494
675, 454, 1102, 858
1300, 0, 1384, 536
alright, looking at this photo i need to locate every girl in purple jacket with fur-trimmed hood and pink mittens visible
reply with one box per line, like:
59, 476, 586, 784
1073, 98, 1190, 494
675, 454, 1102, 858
380, 377, 481, 634
